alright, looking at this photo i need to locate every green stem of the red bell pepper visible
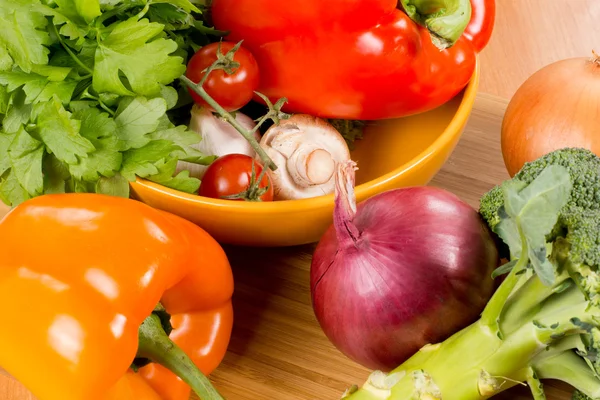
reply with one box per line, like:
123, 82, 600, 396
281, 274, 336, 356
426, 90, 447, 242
400, 0, 471, 50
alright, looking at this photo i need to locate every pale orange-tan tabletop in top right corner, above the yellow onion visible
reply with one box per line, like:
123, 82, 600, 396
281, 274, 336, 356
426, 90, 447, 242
479, 0, 600, 99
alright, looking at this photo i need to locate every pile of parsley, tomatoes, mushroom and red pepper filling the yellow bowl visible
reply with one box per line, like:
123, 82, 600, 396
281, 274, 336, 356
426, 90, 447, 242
0, 0, 495, 206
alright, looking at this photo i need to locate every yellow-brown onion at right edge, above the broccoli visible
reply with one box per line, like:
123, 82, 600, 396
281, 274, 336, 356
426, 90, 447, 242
501, 53, 600, 177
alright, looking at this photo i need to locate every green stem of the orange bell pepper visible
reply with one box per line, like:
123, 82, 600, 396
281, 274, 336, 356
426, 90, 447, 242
137, 313, 223, 400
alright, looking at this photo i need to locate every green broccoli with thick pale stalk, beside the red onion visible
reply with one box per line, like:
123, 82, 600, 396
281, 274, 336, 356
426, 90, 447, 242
343, 148, 600, 400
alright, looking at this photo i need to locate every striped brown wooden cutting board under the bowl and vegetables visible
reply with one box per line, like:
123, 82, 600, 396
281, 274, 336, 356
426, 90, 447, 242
0, 94, 572, 400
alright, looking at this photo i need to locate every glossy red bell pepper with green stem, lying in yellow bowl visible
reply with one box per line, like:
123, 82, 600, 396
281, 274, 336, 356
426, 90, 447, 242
211, 0, 495, 120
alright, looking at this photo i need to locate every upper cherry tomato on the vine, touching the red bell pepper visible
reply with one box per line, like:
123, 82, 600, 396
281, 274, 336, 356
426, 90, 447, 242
185, 42, 259, 111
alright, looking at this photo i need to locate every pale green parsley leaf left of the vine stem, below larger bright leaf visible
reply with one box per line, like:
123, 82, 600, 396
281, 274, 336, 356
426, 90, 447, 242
115, 97, 167, 150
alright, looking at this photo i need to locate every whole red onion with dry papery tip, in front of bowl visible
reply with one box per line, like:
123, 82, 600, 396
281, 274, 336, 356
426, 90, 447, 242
310, 162, 499, 371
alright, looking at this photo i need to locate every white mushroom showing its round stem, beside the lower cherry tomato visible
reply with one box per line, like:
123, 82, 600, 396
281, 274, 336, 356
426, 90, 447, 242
260, 114, 350, 200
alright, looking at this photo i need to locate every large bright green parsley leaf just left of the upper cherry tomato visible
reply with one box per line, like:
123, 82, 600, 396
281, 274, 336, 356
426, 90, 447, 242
93, 17, 185, 96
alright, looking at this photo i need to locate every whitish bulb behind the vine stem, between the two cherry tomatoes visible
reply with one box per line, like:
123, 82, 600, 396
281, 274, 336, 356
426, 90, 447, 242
177, 105, 260, 179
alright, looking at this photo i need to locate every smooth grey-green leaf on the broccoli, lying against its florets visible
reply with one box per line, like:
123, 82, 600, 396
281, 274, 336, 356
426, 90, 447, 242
496, 165, 572, 285
